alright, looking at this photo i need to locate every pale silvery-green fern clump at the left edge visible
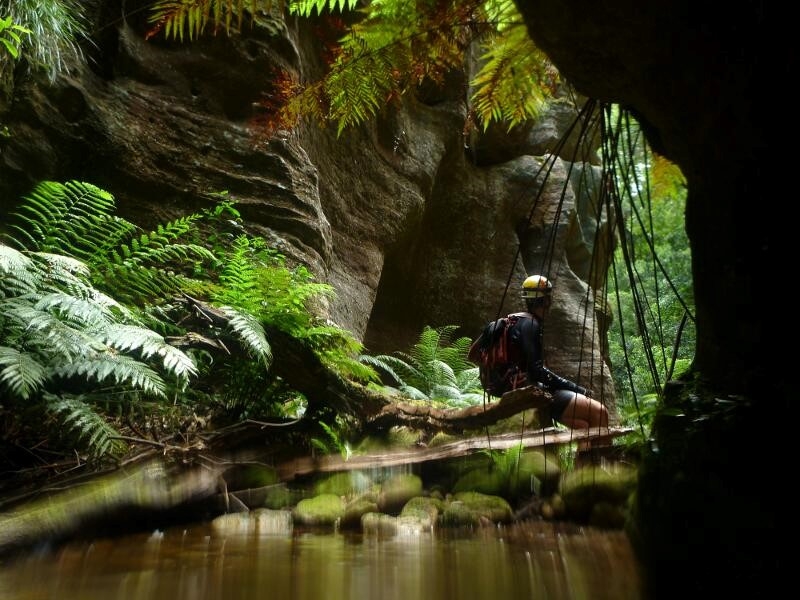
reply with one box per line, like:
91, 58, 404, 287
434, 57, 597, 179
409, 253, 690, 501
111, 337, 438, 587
0, 244, 195, 458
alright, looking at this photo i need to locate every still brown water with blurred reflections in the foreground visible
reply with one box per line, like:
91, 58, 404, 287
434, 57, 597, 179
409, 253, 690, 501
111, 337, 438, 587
0, 521, 642, 600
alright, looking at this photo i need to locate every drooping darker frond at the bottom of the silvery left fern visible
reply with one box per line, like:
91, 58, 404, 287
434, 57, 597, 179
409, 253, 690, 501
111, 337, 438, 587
45, 394, 125, 459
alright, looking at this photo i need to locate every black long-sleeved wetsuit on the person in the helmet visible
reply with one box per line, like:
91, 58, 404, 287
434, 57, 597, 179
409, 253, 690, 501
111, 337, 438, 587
510, 313, 589, 420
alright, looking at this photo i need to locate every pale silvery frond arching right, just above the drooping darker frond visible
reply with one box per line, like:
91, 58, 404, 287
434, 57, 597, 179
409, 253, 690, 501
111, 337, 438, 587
54, 352, 166, 398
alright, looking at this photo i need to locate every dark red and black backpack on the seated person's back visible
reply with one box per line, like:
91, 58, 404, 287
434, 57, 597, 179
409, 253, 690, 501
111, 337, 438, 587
467, 313, 527, 398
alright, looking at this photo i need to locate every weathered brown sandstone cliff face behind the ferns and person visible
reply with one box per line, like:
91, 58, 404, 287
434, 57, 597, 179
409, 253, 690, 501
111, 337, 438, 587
0, 2, 613, 401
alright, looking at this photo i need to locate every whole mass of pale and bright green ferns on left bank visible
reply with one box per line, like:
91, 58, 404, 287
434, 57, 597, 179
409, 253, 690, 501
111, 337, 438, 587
0, 181, 368, 458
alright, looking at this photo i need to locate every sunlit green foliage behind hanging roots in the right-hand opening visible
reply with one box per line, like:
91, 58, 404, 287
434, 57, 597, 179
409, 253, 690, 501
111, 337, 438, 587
609, 112, 695, 431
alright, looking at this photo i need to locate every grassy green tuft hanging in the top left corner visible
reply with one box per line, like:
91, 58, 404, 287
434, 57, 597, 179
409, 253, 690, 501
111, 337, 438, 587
0, 0, 89, 81
